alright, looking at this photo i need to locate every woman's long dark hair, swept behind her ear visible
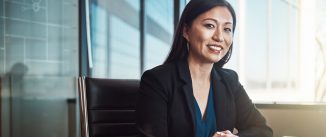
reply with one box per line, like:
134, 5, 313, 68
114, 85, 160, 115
164, 0, 236, 67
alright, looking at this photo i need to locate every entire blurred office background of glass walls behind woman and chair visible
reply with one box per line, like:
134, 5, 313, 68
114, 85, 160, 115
0, 0, 326, 137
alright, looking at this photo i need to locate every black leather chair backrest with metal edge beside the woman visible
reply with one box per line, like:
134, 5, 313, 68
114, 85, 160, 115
78, 77, 139, 137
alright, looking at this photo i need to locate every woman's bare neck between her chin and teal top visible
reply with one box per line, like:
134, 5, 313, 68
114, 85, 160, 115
188, 57, 214, 82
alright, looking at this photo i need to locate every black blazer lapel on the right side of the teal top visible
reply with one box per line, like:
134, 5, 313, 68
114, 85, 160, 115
211, 67, 227, 131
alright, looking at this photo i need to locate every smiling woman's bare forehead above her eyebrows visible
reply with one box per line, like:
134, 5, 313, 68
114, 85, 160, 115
195, 6, 233, 23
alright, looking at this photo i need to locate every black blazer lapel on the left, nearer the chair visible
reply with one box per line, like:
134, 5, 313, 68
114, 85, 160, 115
177, 60, 195, 132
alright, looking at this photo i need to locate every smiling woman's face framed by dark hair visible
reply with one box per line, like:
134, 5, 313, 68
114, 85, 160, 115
183, 6, 233, 63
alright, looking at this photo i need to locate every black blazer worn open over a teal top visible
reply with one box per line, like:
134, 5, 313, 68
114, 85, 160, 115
136, 60, 273, 137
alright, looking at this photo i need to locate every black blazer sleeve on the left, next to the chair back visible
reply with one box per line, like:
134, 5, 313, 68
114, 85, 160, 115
136, 70, 168, 137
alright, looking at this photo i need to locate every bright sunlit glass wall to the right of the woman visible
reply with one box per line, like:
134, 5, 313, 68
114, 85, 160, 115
226, 0, 326, 103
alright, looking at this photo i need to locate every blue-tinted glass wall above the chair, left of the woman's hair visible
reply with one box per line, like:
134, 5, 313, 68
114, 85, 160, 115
90, 0, 181, 79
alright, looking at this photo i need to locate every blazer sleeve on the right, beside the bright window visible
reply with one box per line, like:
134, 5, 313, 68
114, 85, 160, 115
231, 71, 273, 137
